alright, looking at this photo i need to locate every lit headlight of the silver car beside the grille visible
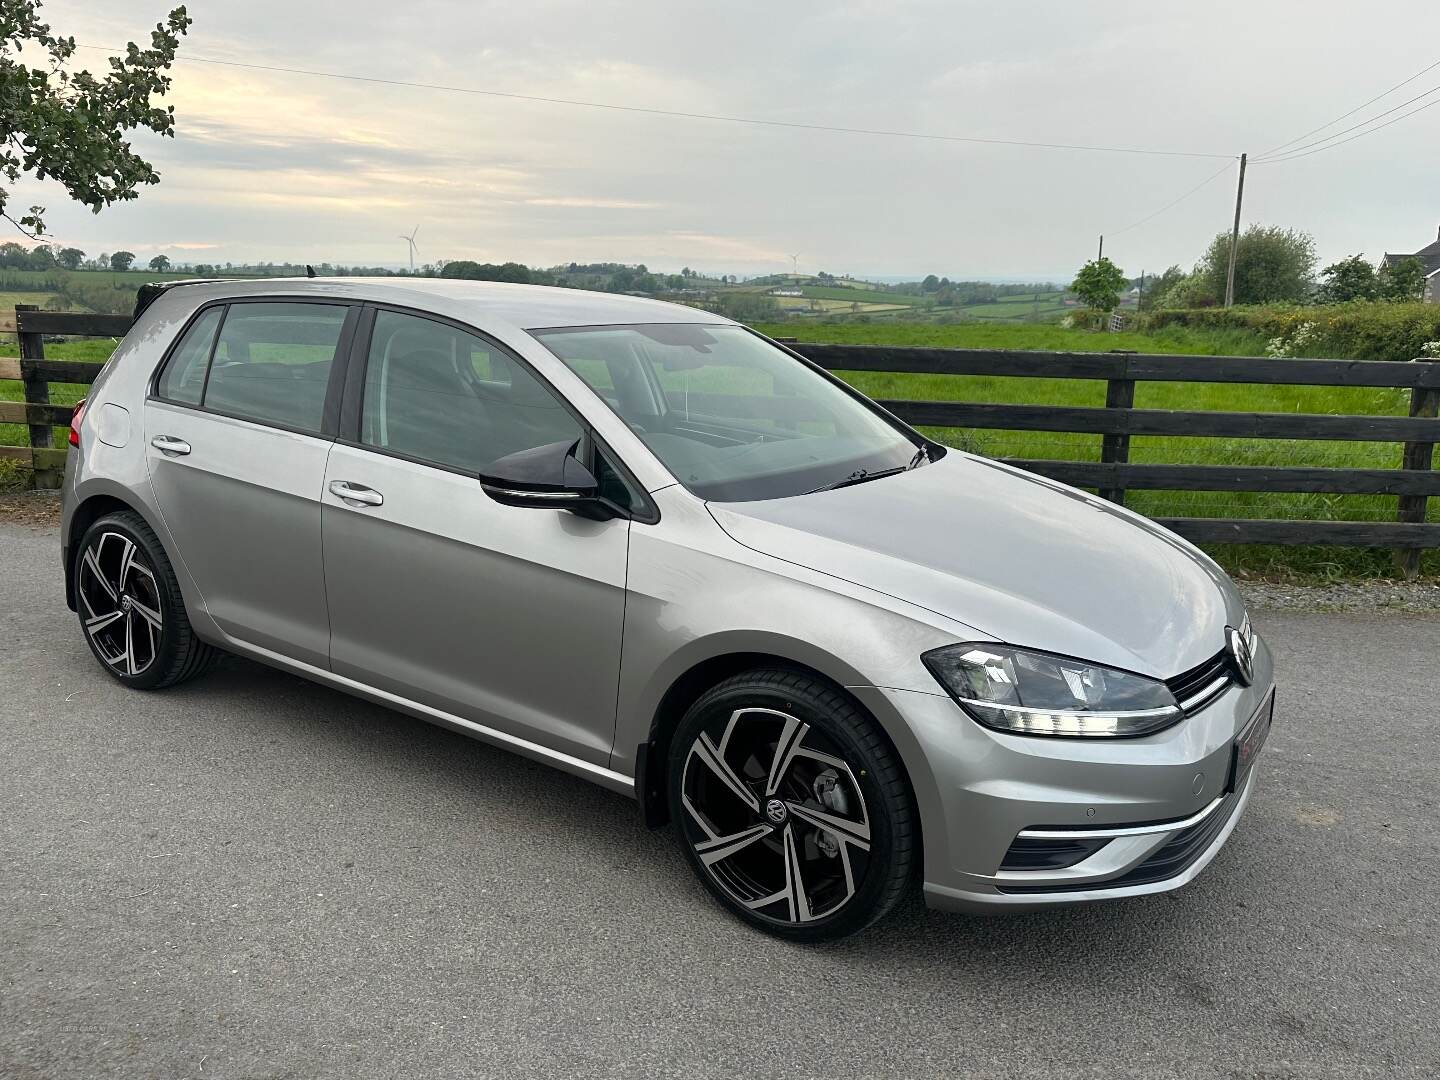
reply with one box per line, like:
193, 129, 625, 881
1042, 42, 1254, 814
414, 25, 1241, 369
922, 642, 1184, 739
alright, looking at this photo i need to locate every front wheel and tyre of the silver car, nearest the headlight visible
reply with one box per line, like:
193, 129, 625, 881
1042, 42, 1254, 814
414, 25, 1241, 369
668, 670, 919, 942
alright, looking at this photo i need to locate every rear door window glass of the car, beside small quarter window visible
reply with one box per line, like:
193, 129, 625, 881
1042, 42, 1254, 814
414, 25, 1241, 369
202, 304, 348, 432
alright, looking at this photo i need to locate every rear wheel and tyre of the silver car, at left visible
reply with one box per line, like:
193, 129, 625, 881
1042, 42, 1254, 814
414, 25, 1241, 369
75, 511, 219, 690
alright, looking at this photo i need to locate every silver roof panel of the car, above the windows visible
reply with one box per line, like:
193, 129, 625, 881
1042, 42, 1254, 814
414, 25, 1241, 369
163, 278, 730, 330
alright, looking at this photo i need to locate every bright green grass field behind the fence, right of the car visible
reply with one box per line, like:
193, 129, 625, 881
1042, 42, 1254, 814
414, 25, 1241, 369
759, 324, 1440, 577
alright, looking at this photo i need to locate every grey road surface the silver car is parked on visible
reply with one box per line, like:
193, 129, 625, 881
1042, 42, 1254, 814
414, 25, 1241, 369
0, 523, 1440, 1080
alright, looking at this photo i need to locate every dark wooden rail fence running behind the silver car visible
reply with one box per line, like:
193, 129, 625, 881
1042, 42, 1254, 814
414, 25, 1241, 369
0, 307, 1440, 575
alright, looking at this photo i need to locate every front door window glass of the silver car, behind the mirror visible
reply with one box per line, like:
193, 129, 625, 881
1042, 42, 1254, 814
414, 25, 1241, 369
360, 311, 580, 472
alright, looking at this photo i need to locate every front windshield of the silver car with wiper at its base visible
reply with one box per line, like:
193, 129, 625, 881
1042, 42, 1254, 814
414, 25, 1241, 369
531, 323, 916, 503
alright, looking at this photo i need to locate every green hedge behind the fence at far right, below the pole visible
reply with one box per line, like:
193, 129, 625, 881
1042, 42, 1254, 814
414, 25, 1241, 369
1143, 301, 1440, 360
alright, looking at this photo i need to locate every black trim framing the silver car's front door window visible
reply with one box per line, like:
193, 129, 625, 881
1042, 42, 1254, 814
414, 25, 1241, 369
336, 301, 660, 524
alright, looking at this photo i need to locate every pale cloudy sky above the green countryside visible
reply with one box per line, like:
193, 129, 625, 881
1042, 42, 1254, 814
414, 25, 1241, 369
12, 0, 1440, 279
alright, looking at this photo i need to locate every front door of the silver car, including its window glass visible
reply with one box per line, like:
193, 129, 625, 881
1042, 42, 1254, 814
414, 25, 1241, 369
323, 310, 629, 765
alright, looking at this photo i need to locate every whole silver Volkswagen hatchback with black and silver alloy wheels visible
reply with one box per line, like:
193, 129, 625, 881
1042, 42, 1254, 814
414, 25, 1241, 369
62, 278, 1274, 940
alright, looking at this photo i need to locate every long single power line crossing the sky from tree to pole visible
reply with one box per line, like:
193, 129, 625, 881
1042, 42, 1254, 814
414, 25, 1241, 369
78, 45, 1234, 158
